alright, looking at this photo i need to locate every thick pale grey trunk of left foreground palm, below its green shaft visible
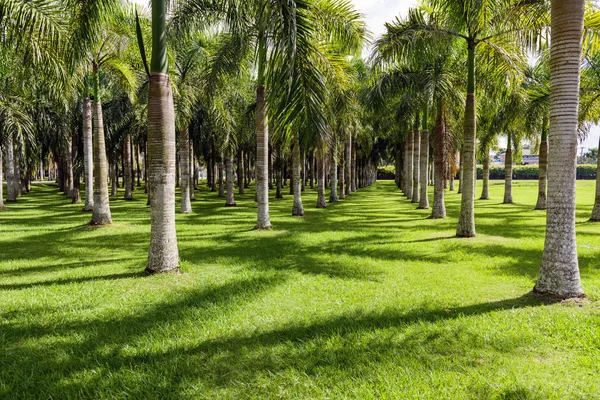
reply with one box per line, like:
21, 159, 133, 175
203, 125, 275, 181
146, 72, 179, 274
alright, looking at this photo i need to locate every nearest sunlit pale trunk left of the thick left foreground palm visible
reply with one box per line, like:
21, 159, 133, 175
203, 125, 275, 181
90, 101, 112, 225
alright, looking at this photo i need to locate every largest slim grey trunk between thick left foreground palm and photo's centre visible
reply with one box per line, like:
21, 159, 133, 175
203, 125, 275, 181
254, 85, 271, 229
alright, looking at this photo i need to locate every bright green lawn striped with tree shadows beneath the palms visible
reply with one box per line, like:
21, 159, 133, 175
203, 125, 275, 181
0, 181, 600, 399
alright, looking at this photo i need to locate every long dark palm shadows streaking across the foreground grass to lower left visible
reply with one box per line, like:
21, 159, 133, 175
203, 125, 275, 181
0, 273, 543, 398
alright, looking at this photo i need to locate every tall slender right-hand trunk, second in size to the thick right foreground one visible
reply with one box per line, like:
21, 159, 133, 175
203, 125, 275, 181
456, 41, 477, 237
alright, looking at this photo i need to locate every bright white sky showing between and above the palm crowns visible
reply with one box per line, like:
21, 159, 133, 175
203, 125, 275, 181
134, 0, 600, 151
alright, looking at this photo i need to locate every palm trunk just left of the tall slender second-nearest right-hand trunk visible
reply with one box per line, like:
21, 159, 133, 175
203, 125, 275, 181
431, 101, 448, 218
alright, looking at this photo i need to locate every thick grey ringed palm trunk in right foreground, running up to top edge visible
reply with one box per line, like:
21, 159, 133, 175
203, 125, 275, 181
534, 0, 585, 298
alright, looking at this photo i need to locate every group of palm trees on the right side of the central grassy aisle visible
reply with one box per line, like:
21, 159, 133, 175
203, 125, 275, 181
372, 0, 600, 298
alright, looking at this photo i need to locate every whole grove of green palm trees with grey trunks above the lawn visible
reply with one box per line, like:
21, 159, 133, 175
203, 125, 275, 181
0, 0, 600, 297
